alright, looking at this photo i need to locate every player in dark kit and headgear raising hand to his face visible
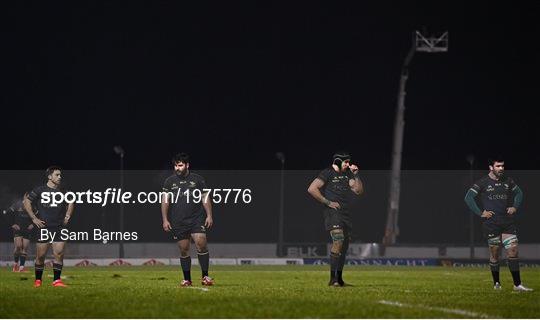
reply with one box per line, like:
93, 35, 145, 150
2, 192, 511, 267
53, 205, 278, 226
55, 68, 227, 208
308, 152, 364, 286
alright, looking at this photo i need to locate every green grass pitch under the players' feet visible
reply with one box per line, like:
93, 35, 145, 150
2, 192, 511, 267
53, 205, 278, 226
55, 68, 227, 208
0, 266, 540, 318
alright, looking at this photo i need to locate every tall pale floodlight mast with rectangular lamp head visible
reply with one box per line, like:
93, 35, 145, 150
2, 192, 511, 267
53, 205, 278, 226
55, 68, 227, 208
383, 31, 448, 245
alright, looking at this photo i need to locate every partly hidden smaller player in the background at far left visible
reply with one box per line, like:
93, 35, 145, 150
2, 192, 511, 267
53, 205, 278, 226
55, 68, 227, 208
6, 194, 34, 272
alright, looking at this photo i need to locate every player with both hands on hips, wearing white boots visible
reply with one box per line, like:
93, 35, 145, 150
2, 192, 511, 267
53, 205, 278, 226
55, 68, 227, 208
465, 159, 532, 291
